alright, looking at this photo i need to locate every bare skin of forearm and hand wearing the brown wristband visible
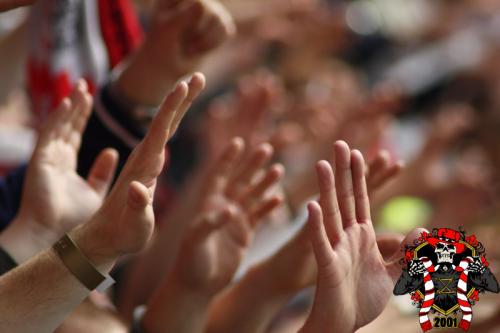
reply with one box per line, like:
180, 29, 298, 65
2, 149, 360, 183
0, 74, 204, 333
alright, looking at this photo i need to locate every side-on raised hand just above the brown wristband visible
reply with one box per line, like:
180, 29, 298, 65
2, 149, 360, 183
73, 74, 205, 268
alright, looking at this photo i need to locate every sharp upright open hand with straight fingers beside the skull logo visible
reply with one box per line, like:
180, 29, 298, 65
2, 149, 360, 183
301, 141, 400, 332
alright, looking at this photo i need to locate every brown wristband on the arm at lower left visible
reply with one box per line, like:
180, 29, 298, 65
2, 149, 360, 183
52, 234, 115, 292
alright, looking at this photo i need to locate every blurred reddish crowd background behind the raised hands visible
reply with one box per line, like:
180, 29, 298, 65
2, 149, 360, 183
0, 0, 500, 333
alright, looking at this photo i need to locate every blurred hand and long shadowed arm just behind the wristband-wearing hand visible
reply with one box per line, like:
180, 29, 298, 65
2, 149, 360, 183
119, 138, 283, 318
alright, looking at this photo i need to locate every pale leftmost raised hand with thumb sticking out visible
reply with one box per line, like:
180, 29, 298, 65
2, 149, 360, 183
0, 80, 118, 262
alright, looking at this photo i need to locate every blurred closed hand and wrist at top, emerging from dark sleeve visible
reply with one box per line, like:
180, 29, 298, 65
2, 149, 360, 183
114, 0, 236, 106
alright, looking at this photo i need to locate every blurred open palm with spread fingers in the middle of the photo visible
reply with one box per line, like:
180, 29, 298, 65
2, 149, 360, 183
173, 138, 283, 294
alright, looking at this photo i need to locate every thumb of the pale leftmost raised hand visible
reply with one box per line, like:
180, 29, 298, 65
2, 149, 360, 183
87, 148, 118, 198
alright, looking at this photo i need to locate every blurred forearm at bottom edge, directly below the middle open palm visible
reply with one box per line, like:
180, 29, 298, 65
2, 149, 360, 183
142, 278, 211, 333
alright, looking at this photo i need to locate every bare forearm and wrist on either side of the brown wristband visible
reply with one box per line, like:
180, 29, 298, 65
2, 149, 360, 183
0, 223, 114, 333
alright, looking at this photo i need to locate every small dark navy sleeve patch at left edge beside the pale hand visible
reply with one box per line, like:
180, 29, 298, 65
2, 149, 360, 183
0, 165, 27, 232
